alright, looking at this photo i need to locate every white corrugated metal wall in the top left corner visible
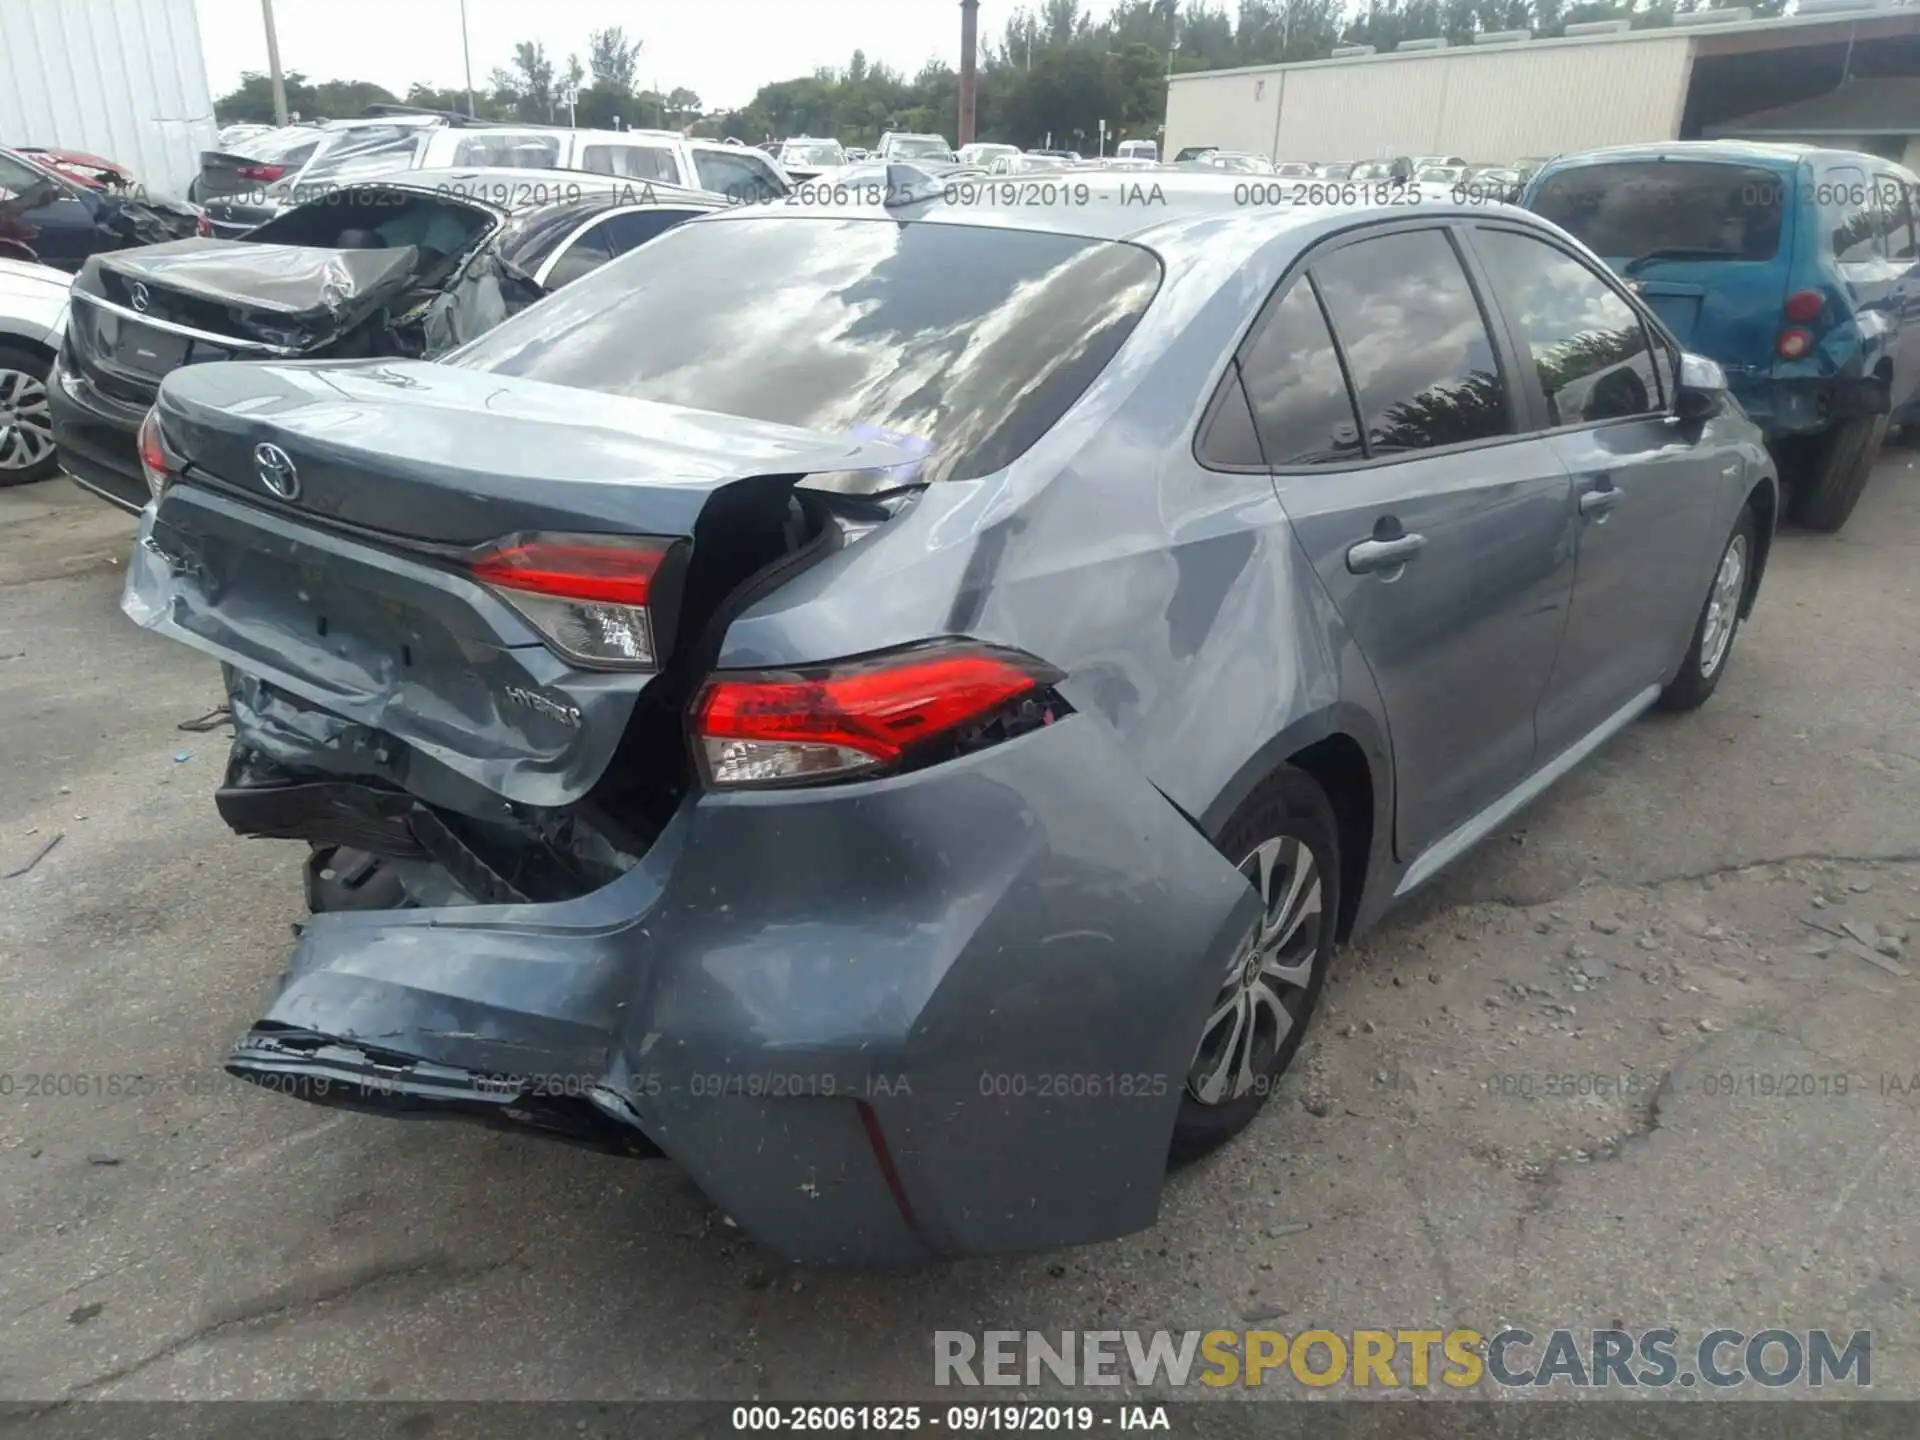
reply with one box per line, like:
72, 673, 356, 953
0, 0, 215, 194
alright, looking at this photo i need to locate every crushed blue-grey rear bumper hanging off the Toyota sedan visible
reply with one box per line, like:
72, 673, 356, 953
228, 716, 1258, 1265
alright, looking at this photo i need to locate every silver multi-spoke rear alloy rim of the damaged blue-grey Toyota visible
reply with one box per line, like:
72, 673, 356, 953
1187, 835, 1325, 1106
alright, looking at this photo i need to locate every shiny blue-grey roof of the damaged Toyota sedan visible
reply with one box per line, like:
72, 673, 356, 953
701, 171, 1551, 263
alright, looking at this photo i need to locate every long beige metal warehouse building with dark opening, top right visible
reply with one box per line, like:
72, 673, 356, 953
1165, 0, 1920, 165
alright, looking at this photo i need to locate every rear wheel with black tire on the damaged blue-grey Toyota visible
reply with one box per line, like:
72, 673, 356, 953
1169, 766, 1340, 1165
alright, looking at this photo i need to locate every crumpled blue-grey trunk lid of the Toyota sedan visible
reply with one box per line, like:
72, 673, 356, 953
123, 361, 914, 820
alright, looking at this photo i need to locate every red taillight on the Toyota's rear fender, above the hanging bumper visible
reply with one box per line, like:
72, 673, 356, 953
691, 641, 1066, 787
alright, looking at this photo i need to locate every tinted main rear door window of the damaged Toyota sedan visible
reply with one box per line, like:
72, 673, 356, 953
1311, 230, 1513, 455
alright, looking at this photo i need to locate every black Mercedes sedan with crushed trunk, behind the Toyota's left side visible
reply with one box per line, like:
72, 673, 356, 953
50, 169, 726, 513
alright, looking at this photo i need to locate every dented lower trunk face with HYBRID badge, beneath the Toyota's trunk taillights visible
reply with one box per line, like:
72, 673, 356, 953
121, 484, 647, 812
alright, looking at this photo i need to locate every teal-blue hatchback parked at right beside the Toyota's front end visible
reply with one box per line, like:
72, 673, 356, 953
1523, 140, 1920, 530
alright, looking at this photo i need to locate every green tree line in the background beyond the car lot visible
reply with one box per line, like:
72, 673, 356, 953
215, 0, 1786, 152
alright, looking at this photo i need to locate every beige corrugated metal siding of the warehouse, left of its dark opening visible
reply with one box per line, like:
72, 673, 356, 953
1167, 35, 1692, 161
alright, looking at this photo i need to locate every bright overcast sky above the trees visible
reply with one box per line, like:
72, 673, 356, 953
198, 0, 1075, 108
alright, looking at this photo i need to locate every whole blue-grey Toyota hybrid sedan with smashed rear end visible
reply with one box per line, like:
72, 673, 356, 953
125, 175, 1778, 1265
